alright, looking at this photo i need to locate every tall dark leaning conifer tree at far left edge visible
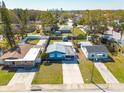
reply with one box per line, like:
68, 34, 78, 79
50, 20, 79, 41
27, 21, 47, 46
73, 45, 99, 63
0, 1, 15, 48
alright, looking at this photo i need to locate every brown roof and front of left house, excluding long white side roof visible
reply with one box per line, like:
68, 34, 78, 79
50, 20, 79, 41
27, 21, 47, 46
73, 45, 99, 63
0, 44, 32, 67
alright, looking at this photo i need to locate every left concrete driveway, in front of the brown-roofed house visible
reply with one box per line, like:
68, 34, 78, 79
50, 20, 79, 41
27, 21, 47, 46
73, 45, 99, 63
8, 69, 36, 86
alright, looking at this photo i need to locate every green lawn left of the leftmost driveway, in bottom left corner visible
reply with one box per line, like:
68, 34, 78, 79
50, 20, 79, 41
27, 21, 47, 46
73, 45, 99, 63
0, 67, 14, 85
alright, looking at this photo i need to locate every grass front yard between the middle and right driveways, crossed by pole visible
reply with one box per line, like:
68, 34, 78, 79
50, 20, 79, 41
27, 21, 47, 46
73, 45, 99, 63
78, 49, 105, 84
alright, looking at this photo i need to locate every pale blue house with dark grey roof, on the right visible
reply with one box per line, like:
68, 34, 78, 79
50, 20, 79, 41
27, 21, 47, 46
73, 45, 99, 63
81, 43, 108, 60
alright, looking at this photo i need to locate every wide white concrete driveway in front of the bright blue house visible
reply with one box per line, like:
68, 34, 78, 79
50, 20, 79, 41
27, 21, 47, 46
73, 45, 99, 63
62, 61, 84, 84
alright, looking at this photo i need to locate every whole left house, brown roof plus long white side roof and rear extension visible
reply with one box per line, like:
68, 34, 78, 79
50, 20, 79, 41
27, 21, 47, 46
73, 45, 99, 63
0, 36, 47, 67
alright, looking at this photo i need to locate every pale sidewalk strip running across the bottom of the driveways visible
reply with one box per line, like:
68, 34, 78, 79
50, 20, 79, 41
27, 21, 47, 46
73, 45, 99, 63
0, 84, 124, 92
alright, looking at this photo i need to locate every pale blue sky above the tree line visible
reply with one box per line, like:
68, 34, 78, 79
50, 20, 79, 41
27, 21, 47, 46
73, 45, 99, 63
3, 0, 124, 10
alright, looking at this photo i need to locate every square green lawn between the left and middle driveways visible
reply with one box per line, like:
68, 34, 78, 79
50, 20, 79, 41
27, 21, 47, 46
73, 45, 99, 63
32, 62, 63, 84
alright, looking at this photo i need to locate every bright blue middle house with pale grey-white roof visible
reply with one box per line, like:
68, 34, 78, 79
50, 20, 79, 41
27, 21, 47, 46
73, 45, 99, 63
46, 43, 76, 61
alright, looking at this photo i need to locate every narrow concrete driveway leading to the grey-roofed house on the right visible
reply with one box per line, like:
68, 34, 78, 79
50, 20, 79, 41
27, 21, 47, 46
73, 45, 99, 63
94, 63, 119, 83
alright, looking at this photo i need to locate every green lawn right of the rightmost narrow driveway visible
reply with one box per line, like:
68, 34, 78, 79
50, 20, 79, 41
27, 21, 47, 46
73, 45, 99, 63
104, 55, 124, 83
